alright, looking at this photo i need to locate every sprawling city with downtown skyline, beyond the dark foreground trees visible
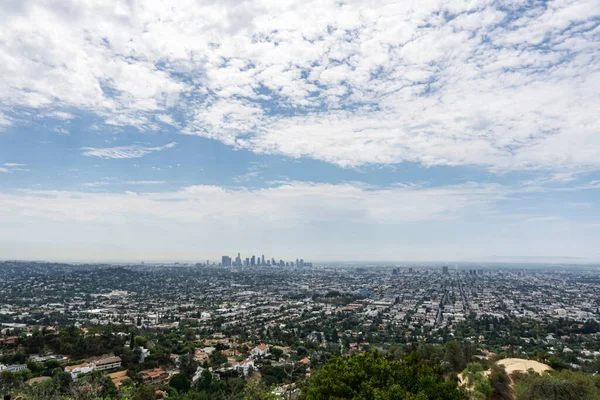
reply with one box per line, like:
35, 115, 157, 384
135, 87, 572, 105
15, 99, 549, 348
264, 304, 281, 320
0, 255, 600, 398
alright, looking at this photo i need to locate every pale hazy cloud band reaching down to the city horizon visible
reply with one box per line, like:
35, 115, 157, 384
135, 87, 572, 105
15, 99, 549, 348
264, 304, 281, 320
0, 181, 598, 260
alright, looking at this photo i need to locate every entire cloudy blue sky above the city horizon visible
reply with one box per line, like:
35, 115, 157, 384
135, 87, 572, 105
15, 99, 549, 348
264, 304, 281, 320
0, 0, 600, 261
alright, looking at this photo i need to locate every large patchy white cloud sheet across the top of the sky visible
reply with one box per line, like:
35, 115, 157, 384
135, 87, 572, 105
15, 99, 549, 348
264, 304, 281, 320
0, 0, 600, 173
